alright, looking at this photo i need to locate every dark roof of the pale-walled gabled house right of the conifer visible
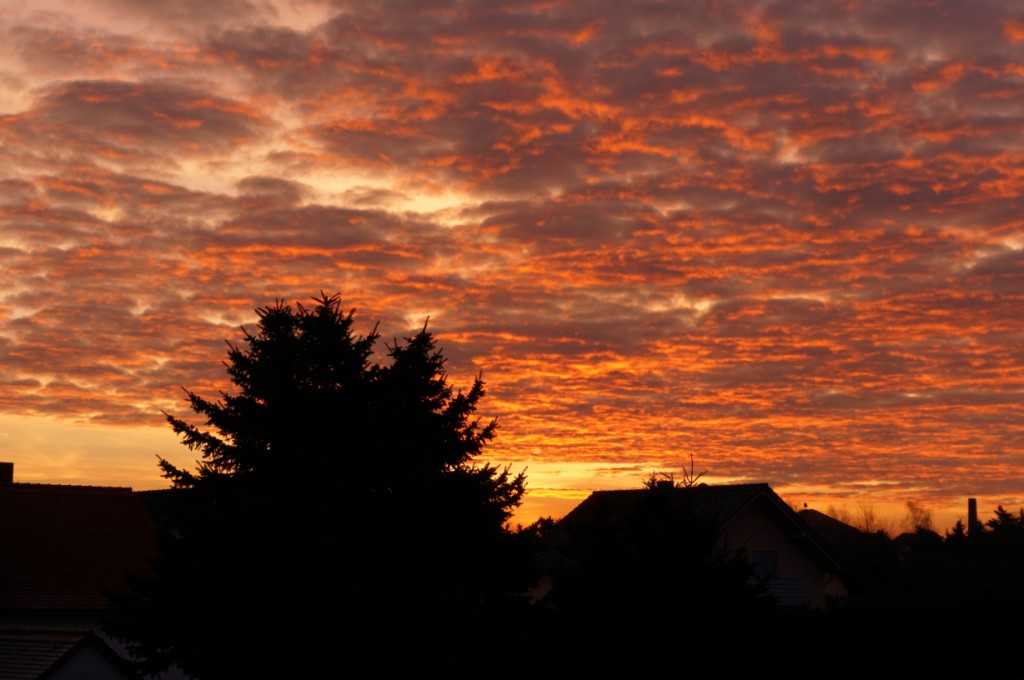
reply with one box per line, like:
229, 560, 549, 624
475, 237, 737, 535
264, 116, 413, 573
552, 483, 850, 578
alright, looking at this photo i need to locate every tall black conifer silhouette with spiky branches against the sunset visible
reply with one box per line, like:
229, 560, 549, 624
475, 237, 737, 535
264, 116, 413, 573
112, 295, 529, 679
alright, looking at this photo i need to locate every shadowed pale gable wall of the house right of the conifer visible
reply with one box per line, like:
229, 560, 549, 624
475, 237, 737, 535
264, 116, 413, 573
719, 502, 847, 608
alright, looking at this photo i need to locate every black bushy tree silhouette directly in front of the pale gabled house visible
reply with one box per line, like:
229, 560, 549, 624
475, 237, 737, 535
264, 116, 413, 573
542, 475, 774, 677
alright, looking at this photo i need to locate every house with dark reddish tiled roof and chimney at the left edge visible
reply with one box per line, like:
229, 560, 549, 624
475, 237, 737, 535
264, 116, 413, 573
0, 463, 157, 680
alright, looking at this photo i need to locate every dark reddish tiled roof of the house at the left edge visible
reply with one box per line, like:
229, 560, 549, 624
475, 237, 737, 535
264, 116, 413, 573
0, 483, 157, 610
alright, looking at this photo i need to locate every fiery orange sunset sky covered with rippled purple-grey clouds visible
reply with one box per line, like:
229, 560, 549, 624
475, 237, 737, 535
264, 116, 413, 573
0, 0, 1024, 528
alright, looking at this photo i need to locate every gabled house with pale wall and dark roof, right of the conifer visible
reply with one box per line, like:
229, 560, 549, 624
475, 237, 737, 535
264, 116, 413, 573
535, 483, 851, 608
